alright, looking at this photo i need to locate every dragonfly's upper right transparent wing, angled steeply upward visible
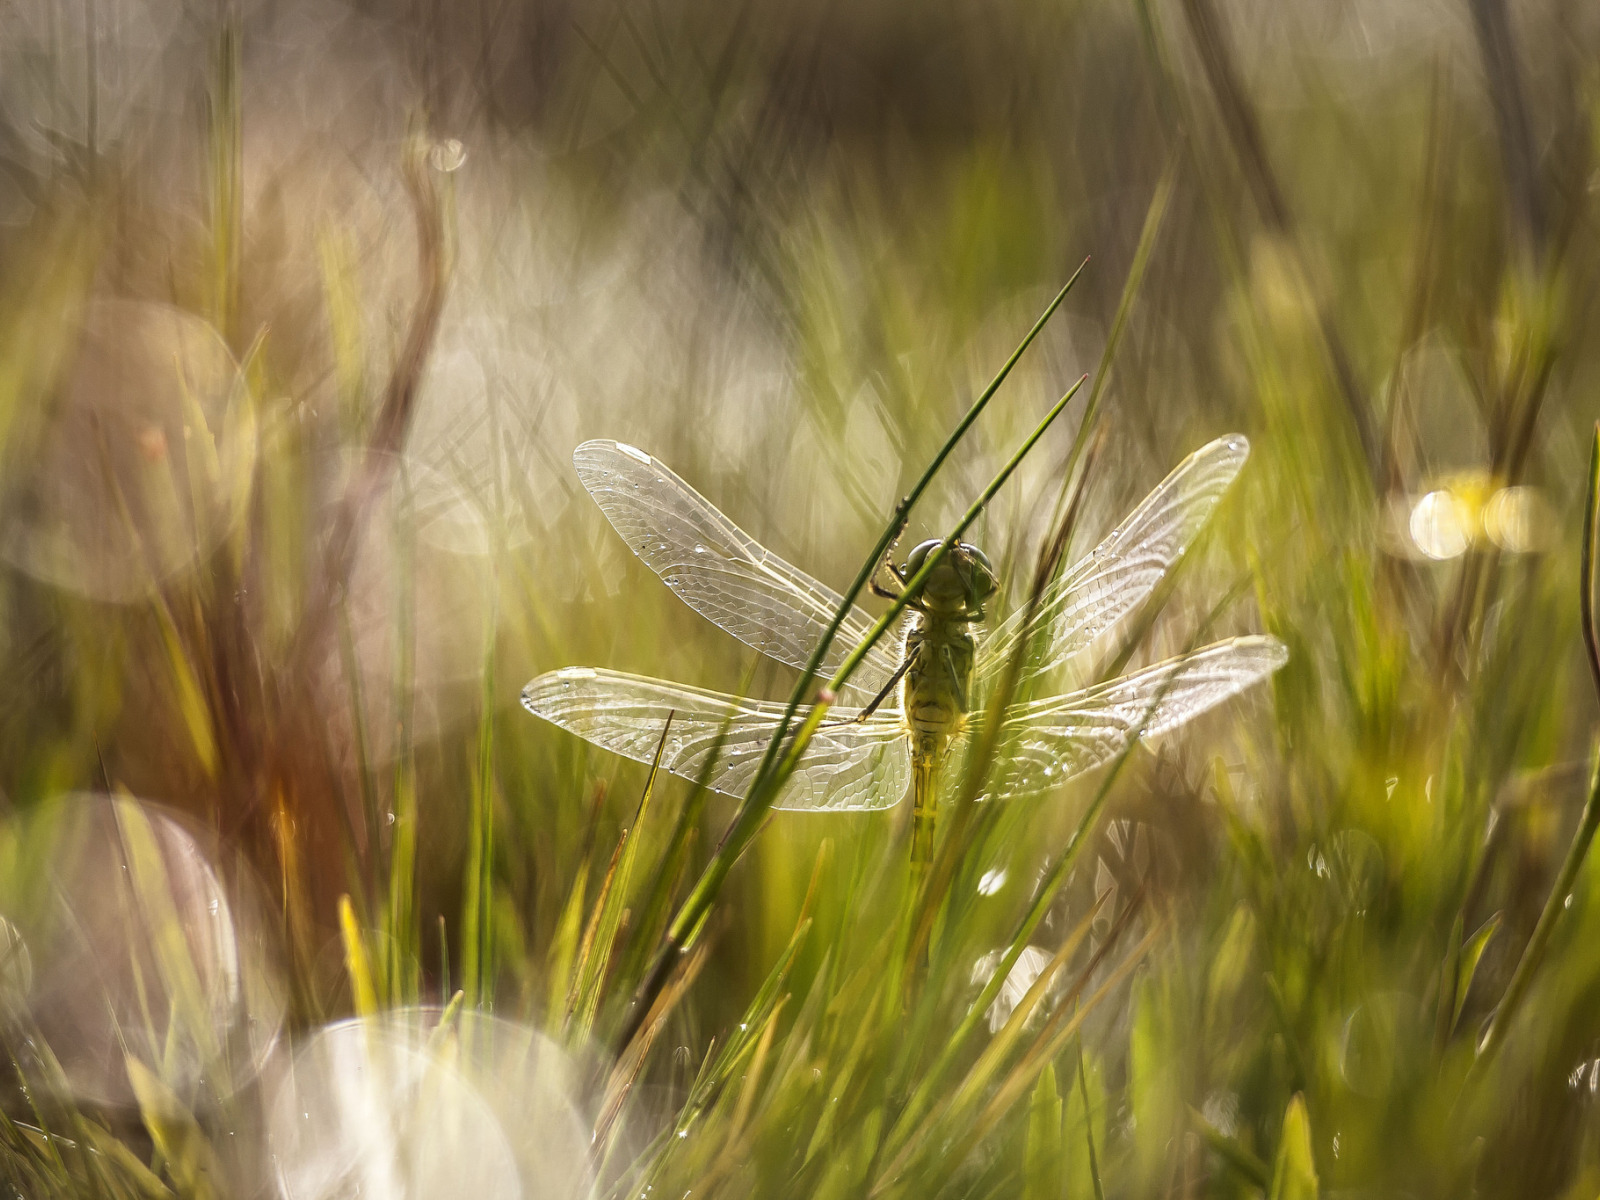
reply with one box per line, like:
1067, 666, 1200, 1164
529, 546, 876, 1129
978, 434, 1250, 678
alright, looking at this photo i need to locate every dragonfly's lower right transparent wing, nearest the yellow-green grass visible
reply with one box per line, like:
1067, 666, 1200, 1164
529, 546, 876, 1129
992, 637, 1288, 795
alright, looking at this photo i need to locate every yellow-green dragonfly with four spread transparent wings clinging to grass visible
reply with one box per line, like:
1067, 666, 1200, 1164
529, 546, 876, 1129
522, 434, 1288, 866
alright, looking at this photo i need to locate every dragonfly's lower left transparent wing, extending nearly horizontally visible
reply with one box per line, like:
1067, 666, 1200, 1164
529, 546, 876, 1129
522, 667, 910, 811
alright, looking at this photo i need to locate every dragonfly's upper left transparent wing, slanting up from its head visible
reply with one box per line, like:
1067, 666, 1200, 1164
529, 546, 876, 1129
573, 440, 898, 696
